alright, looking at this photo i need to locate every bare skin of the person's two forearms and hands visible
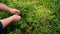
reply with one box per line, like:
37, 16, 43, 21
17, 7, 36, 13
0, 3, 21, 28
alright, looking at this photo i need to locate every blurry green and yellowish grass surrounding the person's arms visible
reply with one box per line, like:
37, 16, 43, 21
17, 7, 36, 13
0, 0, 60, 34
